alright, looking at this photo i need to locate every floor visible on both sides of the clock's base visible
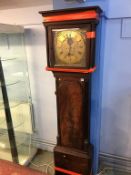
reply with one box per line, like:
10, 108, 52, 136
29, 150, 131, 175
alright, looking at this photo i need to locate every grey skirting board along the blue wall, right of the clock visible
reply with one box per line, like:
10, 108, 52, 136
100, 153, 131, 174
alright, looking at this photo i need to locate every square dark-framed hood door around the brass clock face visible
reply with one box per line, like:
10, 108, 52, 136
47, 24, 96, 69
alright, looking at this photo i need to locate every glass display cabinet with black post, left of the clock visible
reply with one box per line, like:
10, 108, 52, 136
0, 24, 37, 165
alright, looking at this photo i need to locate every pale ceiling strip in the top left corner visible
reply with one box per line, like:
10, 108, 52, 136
0, 0, 53, 10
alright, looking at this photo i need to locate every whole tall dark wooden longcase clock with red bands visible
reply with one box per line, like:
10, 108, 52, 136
40, 7, 101, 175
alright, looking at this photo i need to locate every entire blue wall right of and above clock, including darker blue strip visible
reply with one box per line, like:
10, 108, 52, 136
54, 0, 131, 174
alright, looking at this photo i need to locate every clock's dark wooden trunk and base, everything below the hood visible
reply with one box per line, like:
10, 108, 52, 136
54, 73, 93, 175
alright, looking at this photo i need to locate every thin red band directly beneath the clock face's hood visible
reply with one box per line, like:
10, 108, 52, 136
46, 66, 96, 74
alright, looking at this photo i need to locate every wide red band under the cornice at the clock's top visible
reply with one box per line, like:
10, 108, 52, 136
44, 10, 99, 22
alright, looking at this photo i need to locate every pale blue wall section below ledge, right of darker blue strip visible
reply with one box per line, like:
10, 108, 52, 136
101, 19, 131, 158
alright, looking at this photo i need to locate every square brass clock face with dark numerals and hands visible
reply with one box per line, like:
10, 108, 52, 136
54, 29, 86, 67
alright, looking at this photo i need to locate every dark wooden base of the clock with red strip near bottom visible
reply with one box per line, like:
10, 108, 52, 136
54, 145, 93, 175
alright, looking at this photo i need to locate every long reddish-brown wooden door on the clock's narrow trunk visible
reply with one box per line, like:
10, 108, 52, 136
57, 77, 89, 150
